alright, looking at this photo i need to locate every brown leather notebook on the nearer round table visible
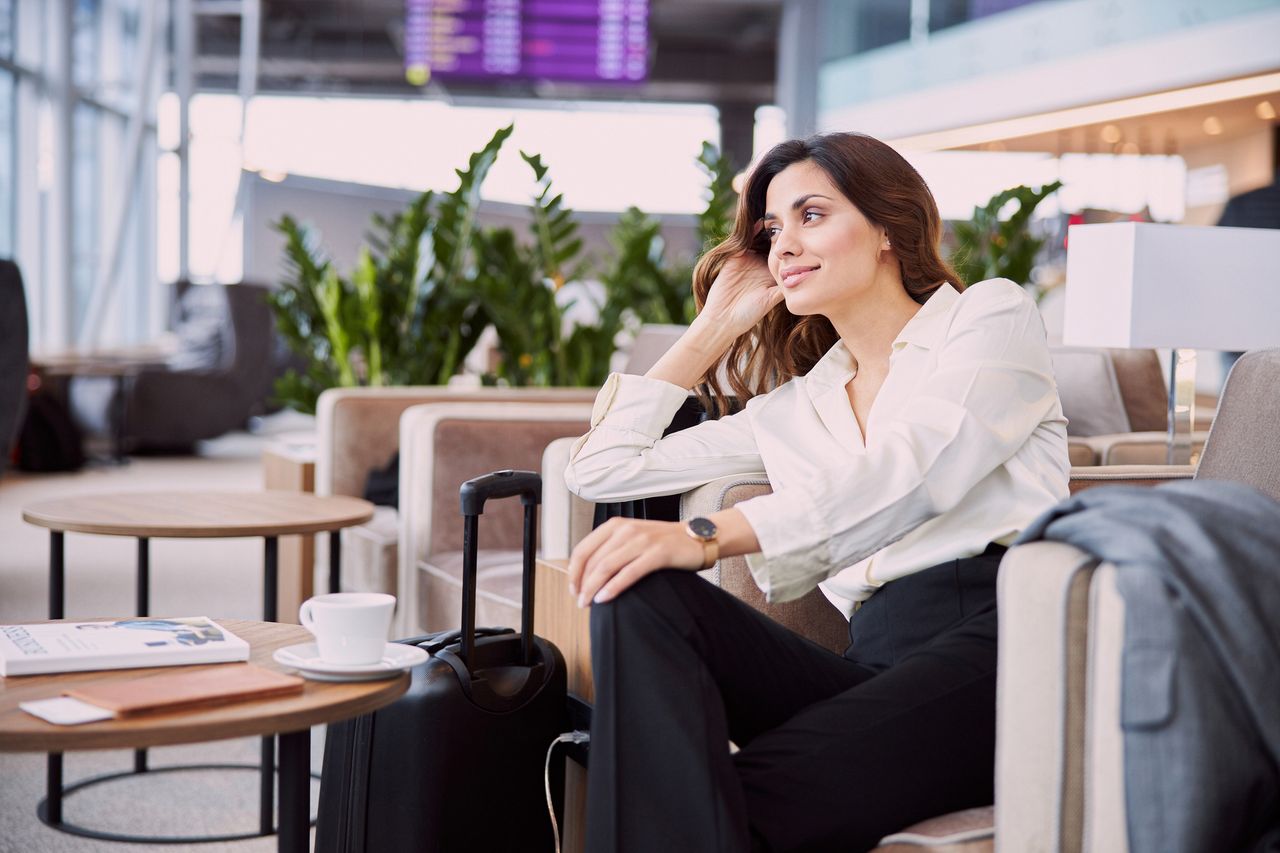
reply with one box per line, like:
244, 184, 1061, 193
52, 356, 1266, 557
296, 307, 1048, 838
65, 663, 303, 717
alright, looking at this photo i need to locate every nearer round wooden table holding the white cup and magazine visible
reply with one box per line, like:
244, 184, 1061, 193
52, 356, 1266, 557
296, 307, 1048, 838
0, 619, 410, 853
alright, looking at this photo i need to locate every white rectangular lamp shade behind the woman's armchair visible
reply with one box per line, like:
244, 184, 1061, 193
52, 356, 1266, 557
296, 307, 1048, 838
1062, 222, 1280, 350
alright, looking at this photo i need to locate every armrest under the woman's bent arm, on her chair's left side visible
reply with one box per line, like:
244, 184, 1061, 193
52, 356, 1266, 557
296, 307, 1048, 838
680, 474, 849, 653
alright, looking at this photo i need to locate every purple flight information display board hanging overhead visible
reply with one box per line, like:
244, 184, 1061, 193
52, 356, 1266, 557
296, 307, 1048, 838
404, 0, 649, 86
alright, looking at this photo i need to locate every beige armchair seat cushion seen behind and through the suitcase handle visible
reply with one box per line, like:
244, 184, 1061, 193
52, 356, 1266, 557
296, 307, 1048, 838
417, 549, 524, 631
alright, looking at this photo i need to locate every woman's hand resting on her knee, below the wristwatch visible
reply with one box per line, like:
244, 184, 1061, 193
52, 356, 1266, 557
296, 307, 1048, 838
568, 519, 704, 607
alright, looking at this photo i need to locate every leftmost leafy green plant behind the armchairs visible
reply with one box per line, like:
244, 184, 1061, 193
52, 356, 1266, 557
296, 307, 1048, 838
269, 126, 513, 412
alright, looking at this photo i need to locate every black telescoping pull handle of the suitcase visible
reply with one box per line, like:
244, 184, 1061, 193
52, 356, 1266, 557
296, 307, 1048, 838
458, 469, 543, 666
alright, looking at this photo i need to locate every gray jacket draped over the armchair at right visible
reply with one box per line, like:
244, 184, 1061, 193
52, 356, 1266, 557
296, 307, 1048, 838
1020, 480, 1280, 853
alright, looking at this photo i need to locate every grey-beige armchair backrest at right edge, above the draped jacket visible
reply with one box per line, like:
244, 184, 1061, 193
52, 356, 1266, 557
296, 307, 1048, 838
1196, 350, 1280, 501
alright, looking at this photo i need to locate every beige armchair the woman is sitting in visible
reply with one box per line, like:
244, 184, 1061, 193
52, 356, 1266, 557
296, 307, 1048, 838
543, 340, 1280, 853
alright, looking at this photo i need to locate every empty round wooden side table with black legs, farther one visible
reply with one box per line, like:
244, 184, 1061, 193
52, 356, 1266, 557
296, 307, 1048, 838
22, 492, 374, 834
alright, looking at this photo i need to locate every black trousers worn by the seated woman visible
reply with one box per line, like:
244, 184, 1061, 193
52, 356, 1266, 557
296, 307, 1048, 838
586, 546, 1004, 853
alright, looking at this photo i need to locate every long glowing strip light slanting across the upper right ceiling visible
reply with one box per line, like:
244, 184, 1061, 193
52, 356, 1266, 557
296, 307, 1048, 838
888, 72, 1280, 151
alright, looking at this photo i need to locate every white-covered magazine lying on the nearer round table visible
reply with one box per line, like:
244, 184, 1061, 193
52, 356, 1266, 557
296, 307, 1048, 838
0, 616, 248, 676
